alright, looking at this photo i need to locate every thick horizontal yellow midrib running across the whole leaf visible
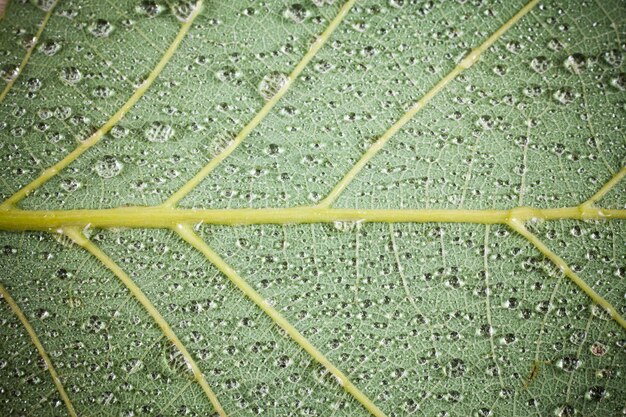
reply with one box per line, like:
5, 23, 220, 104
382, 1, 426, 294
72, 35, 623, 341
0, 205, 626, 231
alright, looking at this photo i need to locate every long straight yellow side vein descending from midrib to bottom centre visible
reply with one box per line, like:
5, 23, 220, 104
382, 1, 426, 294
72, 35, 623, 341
174, 225, 385, 417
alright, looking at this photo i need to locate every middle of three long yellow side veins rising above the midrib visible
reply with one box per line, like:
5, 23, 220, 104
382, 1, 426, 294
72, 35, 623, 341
163, 0, 356, 207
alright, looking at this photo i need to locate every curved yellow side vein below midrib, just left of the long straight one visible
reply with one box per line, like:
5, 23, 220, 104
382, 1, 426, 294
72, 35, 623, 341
61, 227, 226, 417
